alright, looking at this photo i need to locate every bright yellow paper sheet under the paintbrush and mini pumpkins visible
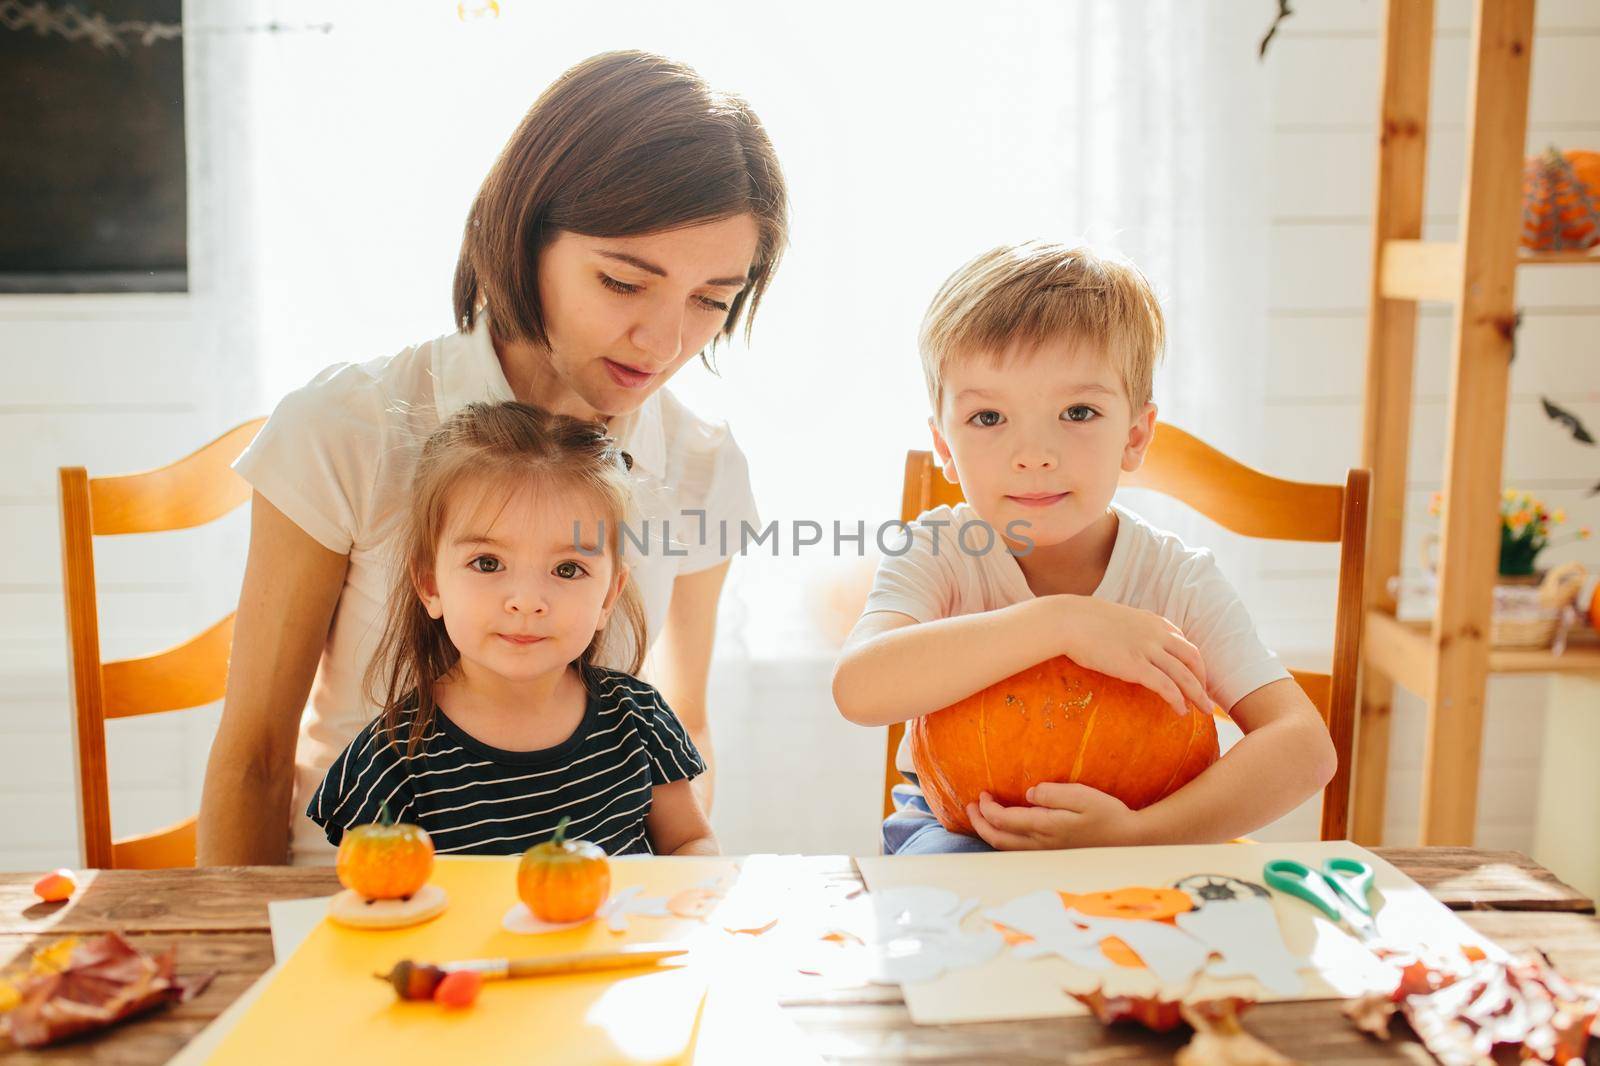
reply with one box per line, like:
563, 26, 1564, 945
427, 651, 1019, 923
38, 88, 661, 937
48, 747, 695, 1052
210, 858, 738, 1066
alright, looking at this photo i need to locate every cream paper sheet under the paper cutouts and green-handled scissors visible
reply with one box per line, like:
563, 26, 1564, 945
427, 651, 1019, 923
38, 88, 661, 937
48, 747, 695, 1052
856, 840, 1499, 1024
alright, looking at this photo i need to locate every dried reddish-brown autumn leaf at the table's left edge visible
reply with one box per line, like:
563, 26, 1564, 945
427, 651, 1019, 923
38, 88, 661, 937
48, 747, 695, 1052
5, 933, 211, 1047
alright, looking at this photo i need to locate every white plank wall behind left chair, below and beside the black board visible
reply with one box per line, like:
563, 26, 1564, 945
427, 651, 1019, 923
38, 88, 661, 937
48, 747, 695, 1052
0, 12, 261, 869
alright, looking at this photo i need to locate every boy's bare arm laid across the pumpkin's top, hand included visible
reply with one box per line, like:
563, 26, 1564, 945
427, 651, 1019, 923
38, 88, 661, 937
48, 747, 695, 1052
834, 595, 1211, 725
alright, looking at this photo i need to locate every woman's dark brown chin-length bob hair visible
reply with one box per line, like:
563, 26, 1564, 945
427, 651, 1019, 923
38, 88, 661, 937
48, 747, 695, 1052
454, 51, 789, 355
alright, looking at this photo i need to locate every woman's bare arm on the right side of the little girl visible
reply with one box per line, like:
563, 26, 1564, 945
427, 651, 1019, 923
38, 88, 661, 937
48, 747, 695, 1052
650, 562, 728, 812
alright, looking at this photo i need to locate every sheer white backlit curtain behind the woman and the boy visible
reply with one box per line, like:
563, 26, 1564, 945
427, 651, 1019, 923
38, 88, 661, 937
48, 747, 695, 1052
206, 0, 1269, 853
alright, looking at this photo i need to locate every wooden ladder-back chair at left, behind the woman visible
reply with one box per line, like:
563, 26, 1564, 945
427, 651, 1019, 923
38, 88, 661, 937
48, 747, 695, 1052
59, 418, 266, 869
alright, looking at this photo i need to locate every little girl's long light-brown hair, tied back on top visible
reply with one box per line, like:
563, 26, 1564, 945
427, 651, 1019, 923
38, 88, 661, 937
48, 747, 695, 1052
366, 403, 645, 754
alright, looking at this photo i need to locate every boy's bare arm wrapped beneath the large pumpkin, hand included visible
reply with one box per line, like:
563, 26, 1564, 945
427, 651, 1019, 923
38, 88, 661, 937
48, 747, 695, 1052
968, 679, 1336, 850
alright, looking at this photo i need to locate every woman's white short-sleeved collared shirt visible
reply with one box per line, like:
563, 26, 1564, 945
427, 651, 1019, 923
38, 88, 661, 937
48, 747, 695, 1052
234, 320, 760, 863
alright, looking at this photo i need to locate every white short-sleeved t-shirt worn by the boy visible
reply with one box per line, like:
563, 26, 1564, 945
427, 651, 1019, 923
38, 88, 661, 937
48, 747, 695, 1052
862, 503, 1290, 770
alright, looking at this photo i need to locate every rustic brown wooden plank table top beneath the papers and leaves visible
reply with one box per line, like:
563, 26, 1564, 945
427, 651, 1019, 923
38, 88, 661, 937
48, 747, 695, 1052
0, 848, 1600, 1066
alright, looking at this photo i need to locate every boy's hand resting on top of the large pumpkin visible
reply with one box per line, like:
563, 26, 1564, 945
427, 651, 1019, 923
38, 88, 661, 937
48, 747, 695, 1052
1061, 595, 1211, 714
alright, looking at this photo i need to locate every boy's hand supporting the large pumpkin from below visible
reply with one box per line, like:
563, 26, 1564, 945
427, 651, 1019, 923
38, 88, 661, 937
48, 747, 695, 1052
966, 783, 1139, 852
